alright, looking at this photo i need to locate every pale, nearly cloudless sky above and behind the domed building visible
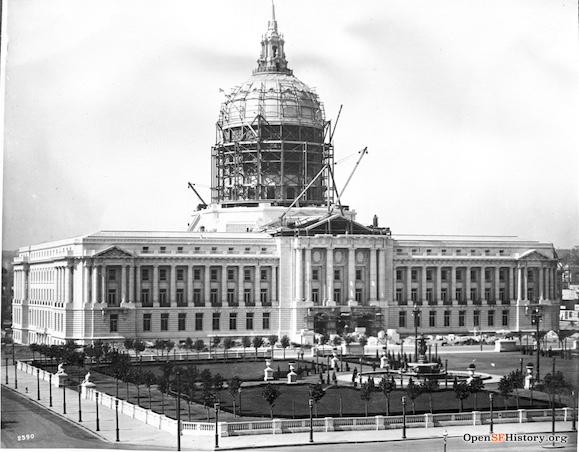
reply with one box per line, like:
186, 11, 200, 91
2, 0, 579, 250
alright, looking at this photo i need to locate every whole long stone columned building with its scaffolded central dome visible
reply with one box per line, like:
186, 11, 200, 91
12, 8, 560, 344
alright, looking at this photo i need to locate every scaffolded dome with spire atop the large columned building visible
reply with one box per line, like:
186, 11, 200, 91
211, 7, 333, 207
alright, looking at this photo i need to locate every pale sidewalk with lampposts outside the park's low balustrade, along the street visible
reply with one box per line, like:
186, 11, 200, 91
2, 363, 571, 451
